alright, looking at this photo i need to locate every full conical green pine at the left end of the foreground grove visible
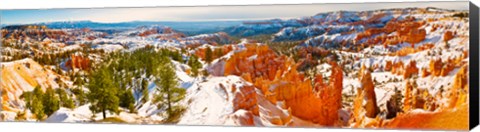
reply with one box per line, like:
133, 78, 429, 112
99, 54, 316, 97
87, 66, 119, 119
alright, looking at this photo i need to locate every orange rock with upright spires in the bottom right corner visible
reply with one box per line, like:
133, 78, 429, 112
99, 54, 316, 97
383, 65, 469, 130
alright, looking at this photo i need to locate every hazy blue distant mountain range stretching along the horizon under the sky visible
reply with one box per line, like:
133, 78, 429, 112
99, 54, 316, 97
1, 7, 464, 37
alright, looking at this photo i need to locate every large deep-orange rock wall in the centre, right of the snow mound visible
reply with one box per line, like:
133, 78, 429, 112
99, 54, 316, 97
225, 44, 343, 126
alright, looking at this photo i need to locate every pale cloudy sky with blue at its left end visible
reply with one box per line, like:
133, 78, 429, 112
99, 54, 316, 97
0, 1, 468, 24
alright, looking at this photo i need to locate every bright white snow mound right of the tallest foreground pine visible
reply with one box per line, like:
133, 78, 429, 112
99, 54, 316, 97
178, 76, 247, 125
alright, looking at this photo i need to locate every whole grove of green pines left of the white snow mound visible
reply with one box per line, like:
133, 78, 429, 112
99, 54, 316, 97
87, 47, 185, 122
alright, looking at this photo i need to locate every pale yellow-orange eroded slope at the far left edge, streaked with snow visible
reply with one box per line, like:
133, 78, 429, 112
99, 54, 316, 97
0, 58, 64, 112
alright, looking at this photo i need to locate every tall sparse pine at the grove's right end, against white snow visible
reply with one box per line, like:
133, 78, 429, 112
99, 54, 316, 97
155, 58, 185, 122
